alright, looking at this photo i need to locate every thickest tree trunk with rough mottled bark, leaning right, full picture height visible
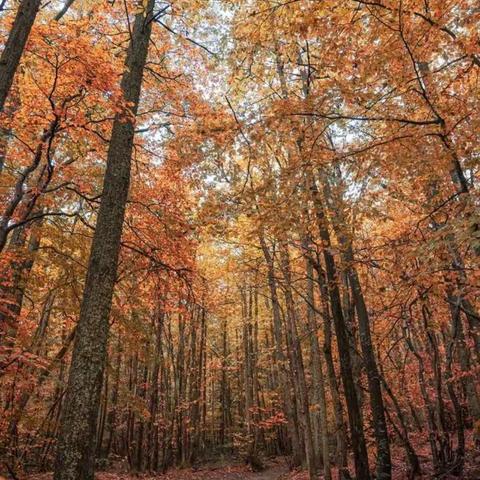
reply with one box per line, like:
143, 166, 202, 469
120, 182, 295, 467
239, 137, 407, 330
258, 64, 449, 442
54, 0, 155, 480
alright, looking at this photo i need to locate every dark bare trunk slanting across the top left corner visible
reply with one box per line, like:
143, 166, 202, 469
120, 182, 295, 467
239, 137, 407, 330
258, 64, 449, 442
0, 0, 41, 112
